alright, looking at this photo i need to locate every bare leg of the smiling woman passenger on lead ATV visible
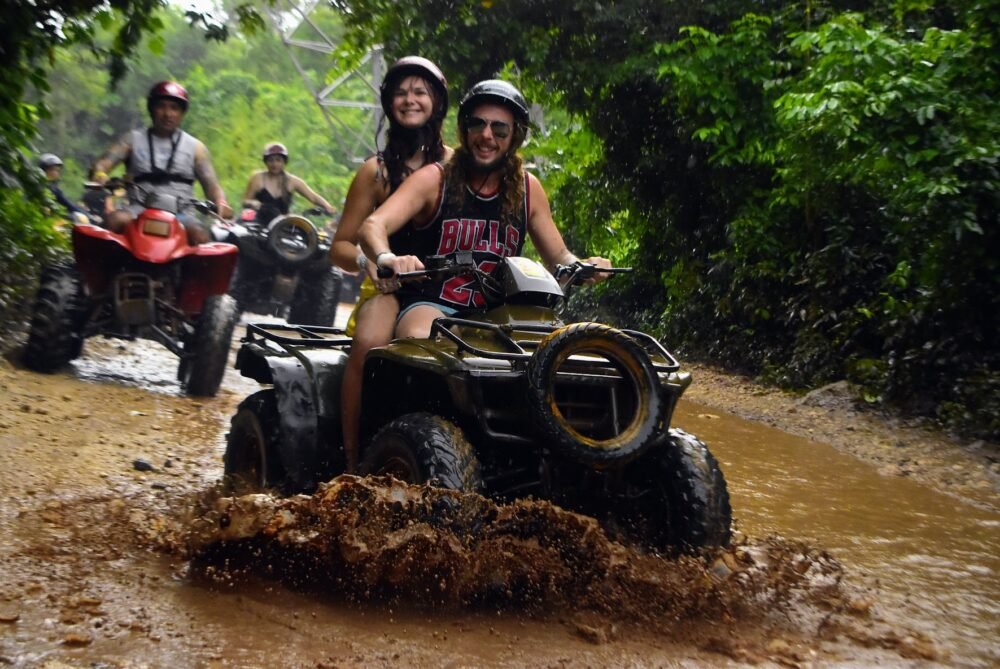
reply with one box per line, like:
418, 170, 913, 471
340, 295, 399, 473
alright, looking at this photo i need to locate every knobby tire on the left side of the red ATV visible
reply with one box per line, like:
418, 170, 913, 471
24, 265, 86, 372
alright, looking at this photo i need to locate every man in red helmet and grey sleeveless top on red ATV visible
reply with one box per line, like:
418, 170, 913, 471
91, 81, 233, 244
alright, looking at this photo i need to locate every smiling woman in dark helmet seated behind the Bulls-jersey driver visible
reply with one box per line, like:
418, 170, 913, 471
330, 56, 452, 471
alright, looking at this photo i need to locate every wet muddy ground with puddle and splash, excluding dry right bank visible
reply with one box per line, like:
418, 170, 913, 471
0, 320, 1000, 667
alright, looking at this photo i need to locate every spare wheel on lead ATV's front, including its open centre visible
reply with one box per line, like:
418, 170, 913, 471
527, 323, 668, 468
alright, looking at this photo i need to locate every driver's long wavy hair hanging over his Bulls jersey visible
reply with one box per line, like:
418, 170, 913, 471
444, 119, 527, 224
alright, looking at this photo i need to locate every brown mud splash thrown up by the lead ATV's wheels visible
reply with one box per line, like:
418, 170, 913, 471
173, 476, 840, 622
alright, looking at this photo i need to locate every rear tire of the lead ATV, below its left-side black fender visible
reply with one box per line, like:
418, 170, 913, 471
223, 389, 287, 495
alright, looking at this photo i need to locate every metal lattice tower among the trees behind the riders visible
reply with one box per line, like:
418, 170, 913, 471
264, 0, 385, 162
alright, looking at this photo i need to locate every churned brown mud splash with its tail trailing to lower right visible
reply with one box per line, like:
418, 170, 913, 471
166, 476, 939, 666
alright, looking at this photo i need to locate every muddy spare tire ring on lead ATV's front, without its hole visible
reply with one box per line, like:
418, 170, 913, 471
527, 323, 667, 468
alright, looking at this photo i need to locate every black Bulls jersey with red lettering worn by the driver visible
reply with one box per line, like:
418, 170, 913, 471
391, 167, 529, 311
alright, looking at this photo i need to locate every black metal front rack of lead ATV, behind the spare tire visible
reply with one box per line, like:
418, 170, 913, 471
431, 316, 680, 373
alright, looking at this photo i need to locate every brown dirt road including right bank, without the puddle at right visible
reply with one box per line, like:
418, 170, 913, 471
0, 330, 997, 668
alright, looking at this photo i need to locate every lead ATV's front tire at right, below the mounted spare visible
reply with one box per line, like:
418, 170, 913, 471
615, 429, 732, 553
